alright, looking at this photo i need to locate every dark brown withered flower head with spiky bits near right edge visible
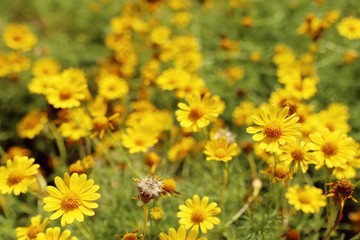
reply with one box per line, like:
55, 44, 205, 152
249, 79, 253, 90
326, 178, 357, 207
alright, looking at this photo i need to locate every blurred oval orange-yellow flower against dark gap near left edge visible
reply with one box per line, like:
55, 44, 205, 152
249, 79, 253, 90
16, 110, 48, 139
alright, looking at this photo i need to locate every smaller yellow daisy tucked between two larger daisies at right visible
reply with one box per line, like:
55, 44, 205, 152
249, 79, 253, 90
279, 141, 317, 173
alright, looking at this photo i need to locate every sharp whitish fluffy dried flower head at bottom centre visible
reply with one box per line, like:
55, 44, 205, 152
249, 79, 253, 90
134, 176, 164, 203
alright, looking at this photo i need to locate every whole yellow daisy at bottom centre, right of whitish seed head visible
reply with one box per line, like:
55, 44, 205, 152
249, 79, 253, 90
176, 195, 221, 233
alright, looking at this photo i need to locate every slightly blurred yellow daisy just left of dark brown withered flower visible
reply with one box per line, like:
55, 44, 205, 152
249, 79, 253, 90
285, 185, 326, 213
